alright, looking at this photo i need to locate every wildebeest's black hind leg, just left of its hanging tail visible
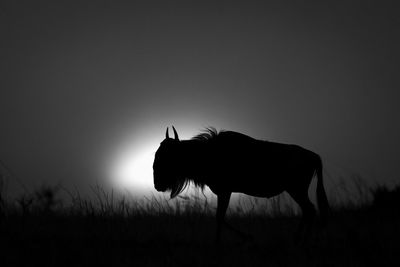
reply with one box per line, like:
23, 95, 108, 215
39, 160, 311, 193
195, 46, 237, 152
288, 190, 316, 243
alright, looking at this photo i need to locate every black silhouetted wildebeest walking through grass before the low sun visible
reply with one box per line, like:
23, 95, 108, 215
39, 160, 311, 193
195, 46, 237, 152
153, 127, 329, 242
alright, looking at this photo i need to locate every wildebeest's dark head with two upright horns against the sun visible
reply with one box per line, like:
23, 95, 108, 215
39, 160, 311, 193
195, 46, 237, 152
153, 126, 186, 198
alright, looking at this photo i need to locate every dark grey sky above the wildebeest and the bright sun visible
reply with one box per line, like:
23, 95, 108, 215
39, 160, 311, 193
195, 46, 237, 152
0, 0, 400, 197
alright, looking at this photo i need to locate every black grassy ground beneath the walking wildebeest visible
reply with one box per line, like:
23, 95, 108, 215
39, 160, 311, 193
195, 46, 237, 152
0, 187, 400, 266
